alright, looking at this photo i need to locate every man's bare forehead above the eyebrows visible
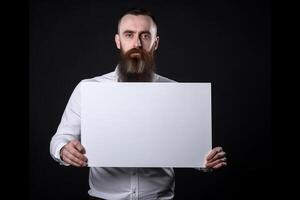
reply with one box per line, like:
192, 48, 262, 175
119, 14, 156, 33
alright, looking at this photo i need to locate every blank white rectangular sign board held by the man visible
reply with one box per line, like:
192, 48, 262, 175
81, 82, 212, 167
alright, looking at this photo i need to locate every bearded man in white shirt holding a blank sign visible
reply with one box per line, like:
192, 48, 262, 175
50, 9, 226, 200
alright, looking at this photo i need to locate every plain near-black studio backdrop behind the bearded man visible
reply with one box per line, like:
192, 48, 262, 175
29, 0, 272, 200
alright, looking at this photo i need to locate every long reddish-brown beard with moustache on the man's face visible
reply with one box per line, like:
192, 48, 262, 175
118, 49, 155, 82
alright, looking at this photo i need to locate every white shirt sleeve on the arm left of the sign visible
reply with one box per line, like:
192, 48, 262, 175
50, 82, 81, 166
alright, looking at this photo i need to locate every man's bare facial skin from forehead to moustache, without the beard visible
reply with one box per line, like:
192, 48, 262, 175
115, 14, 159, 54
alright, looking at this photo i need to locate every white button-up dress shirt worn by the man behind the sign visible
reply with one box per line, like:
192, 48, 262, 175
50, 68, 175, 200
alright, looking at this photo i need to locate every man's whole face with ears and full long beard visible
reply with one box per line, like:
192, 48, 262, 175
115, 14, 159, 82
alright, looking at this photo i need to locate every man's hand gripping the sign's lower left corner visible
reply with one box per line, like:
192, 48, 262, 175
60, 140, 87, 167
